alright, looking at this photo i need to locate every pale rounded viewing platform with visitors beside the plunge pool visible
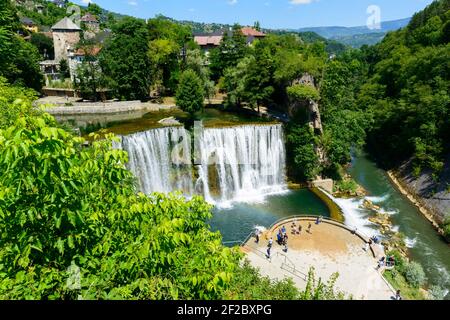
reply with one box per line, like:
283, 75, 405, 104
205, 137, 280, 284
242, 216, 395, 300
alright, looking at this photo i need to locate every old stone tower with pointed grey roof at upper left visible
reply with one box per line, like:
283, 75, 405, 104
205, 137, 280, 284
52, 17, 81, 62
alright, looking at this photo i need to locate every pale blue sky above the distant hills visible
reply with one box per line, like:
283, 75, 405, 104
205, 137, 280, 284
74, 0, 432, 28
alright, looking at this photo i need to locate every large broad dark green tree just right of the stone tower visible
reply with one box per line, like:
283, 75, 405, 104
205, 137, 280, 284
99, 18, 152, 100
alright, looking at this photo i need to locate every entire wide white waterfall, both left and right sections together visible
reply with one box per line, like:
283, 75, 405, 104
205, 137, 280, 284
116, 125, 286, 204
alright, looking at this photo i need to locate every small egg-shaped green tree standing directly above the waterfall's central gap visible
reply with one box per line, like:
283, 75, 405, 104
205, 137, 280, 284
176, 70, 205, 115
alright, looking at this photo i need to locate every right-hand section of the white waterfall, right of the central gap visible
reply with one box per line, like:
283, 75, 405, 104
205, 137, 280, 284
197, 125, 286, 205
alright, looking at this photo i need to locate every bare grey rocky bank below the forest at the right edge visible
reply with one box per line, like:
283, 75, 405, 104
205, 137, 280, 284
395, 155, 450, 224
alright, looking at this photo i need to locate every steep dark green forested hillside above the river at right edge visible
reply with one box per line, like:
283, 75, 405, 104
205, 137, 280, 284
361, 0, 450, 174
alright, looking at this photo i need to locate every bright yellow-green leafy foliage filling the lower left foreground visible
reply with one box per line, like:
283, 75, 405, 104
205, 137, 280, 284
0, 78, 344, 299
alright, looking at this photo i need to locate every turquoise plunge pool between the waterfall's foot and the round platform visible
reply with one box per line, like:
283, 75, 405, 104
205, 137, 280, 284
210, 189, 330, 245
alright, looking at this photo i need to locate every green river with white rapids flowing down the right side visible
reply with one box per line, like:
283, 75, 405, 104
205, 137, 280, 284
349, 154, 450, 298
